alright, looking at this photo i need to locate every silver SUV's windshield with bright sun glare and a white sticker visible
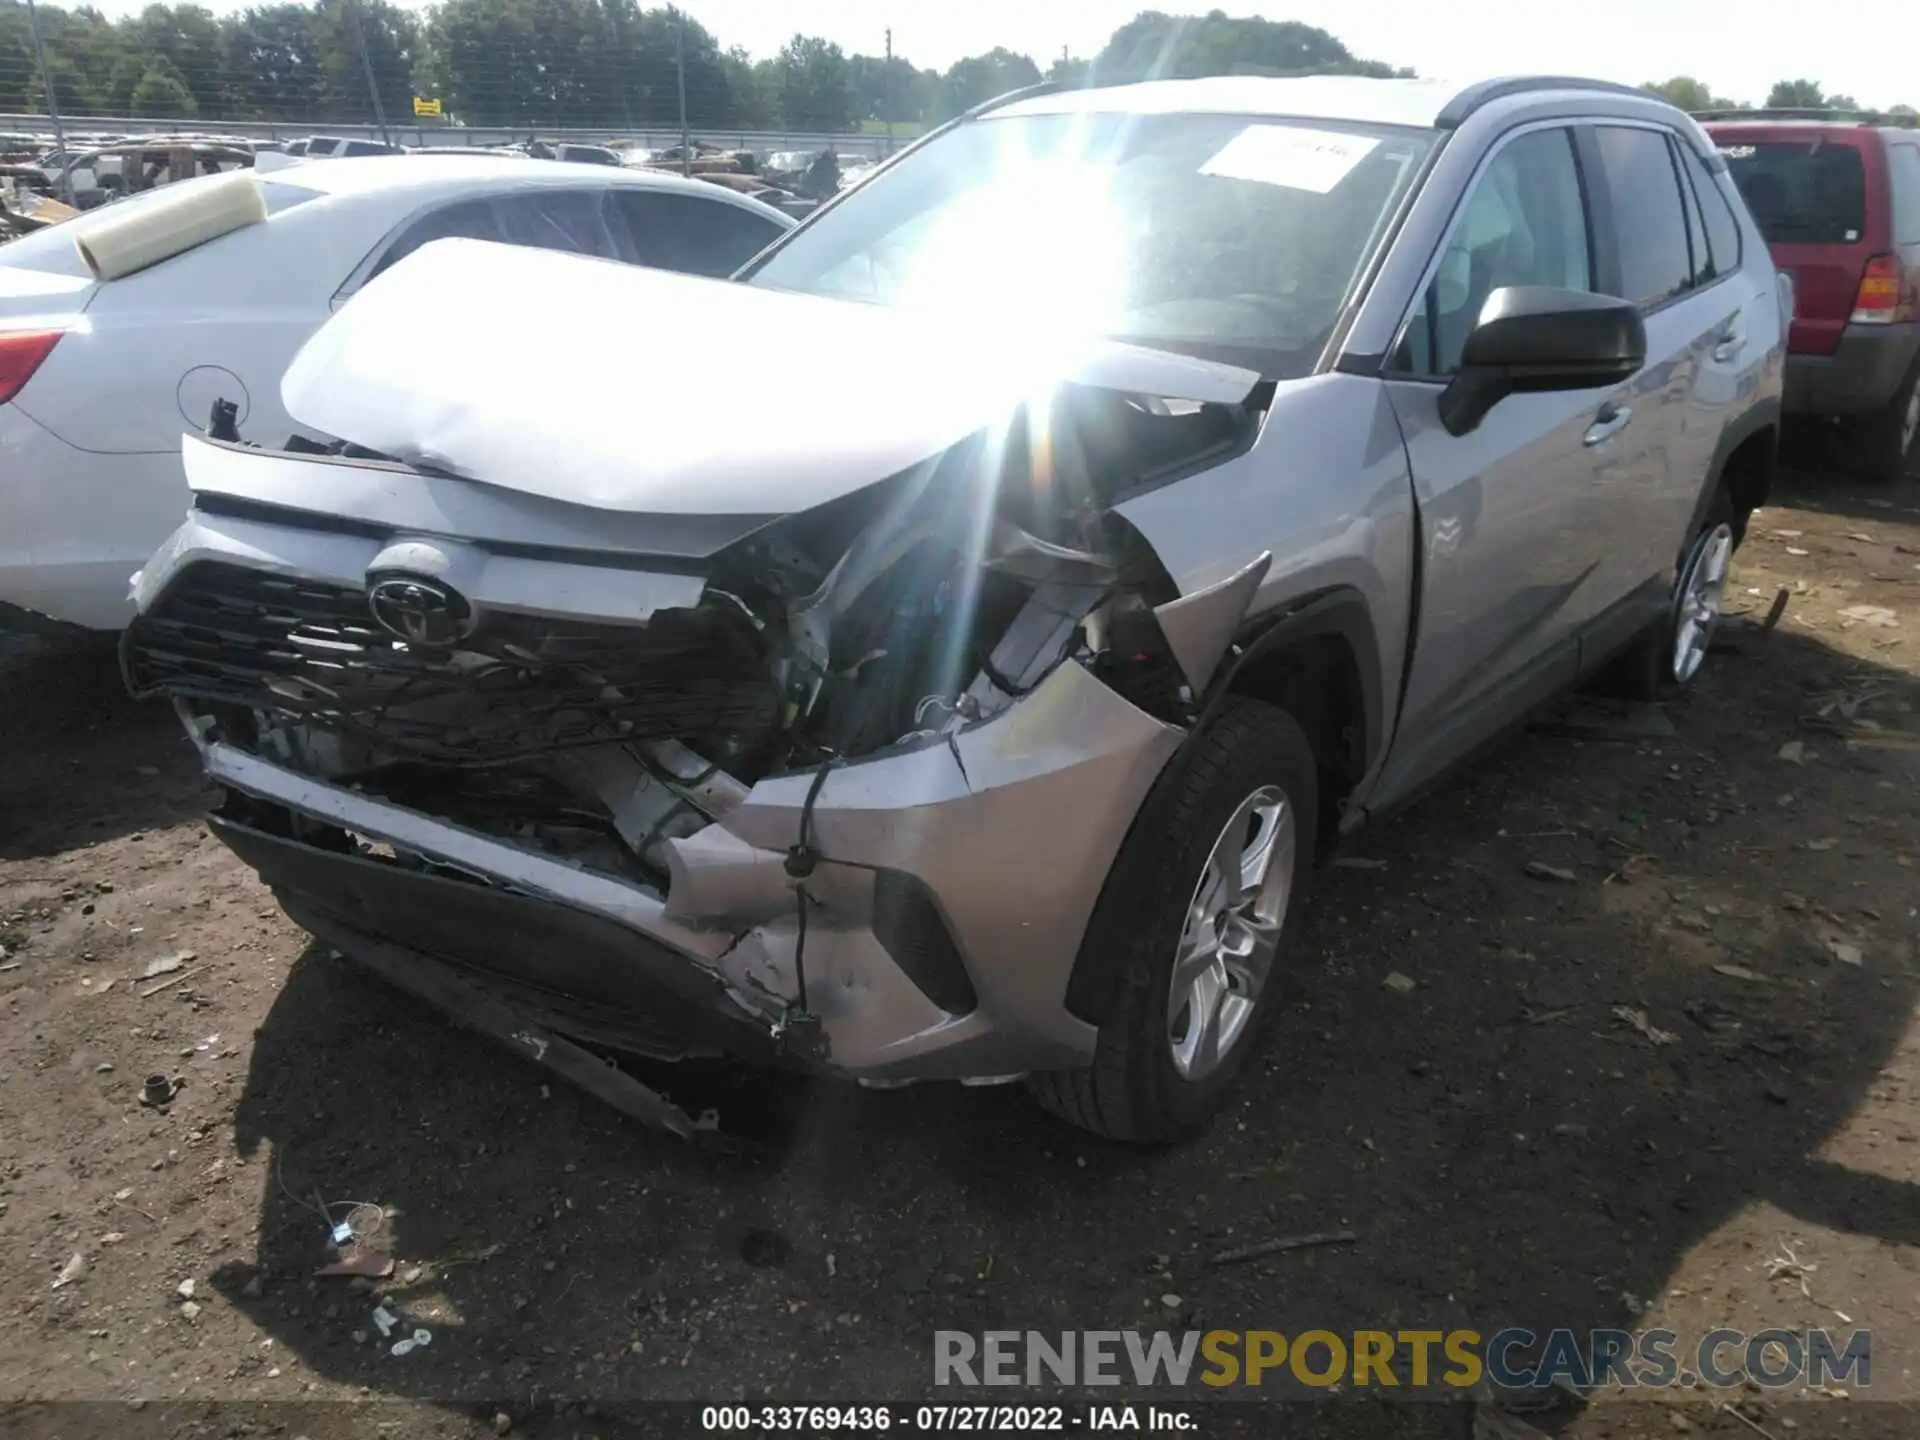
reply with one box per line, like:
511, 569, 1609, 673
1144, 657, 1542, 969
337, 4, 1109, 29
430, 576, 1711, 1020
745, 115, 1432, 378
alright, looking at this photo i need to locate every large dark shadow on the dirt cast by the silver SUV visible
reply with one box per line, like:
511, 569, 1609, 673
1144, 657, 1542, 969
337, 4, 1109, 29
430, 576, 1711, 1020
202, 632, 1920, 1404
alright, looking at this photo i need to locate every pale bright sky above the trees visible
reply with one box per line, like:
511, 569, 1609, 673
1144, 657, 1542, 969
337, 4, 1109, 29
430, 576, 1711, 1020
78, 0, 1920, 106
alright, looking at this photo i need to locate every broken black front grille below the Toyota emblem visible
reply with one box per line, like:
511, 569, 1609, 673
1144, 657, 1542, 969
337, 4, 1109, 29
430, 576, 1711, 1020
123, 561, 780, 764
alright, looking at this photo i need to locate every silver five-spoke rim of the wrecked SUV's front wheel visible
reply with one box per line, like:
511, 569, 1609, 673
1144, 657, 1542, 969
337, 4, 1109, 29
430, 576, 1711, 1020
1167, 785, 1298, 1081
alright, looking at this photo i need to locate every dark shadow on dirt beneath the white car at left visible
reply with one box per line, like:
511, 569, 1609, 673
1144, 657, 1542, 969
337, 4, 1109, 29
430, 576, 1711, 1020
0, 630, 205, 860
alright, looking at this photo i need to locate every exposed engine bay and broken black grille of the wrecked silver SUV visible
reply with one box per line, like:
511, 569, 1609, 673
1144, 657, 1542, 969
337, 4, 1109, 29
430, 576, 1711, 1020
125, 384, 1271, 891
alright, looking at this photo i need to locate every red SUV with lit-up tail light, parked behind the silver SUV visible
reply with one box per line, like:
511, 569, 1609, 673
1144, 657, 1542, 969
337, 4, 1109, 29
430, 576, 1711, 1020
1699, 109, 1920, 480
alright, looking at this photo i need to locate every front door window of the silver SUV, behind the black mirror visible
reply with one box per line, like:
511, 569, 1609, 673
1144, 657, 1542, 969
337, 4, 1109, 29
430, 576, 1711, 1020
1392, 129, 1597, 376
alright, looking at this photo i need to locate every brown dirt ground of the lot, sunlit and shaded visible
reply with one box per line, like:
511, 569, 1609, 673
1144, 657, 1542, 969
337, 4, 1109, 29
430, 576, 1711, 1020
0, 445, 1920, 1440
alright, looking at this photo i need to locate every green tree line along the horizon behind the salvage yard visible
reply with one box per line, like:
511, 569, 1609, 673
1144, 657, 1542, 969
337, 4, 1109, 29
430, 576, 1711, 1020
0, 0, 1904, 132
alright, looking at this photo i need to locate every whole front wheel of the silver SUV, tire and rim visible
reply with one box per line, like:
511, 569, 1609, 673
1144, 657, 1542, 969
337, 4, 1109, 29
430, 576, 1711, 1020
1029, 697, 1319, 1144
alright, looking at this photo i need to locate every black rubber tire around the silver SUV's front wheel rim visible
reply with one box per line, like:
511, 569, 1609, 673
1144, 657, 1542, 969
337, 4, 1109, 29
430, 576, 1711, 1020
1027, 697, 1319, 1144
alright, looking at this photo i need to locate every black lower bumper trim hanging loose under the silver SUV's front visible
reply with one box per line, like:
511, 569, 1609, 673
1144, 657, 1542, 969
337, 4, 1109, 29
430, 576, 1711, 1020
207, 816, 778, 1062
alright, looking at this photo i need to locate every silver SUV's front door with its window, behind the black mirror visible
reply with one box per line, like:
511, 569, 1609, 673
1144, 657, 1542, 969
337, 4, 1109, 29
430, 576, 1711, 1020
1380, 125, 1620, 804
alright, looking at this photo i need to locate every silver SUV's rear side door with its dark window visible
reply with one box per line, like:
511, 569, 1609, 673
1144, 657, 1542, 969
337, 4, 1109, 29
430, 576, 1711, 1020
1588, 123, 1757, 633
